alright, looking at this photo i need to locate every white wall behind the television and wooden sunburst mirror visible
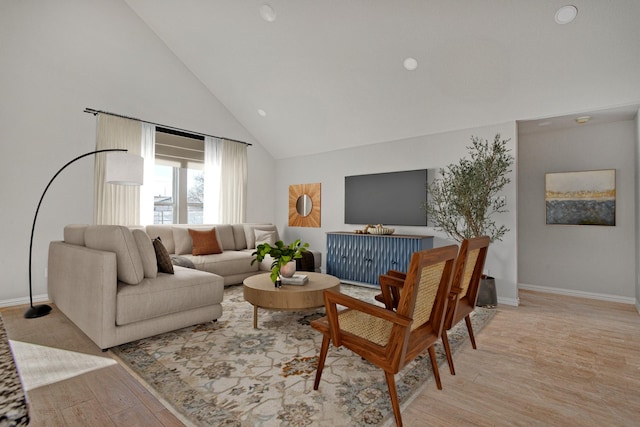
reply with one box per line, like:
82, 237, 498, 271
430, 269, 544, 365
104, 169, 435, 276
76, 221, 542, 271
275, 123, 517, 305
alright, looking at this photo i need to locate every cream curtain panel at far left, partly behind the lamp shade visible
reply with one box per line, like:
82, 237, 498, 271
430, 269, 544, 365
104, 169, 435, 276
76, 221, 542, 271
93, 114, 142, 225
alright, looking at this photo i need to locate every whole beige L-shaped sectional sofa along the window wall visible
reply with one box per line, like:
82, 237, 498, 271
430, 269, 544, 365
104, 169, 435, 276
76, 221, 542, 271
48, 224, 321, 349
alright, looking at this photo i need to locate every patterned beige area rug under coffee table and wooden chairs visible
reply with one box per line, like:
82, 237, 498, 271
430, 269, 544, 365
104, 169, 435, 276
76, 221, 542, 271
112, 284, 495, 426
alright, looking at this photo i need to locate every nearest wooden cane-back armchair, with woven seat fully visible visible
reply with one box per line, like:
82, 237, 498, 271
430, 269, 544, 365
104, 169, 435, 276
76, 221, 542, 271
311, 245, 458, 426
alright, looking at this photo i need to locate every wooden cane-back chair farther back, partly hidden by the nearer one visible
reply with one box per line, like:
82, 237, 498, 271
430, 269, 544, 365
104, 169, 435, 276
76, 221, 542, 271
442, 236, 489, 375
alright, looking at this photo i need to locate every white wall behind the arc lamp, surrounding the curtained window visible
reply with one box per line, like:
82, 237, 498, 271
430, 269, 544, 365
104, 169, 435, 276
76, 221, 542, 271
0, 0, 275, 305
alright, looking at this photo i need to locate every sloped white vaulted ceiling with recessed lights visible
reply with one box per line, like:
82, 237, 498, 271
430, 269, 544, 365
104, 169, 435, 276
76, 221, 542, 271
125, 0, 640, 159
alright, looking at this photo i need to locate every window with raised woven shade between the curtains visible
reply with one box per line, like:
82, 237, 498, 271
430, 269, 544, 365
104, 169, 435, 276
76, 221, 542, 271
153, 128, 204, 224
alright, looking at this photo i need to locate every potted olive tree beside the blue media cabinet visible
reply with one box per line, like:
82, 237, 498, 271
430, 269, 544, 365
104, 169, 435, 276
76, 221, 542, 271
423, 133, 514, 305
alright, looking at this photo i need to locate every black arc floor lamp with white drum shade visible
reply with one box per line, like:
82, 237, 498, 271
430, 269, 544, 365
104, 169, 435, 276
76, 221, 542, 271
24, 148, 144, 319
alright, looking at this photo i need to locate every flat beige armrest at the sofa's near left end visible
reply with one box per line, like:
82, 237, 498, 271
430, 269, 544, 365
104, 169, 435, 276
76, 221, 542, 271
48, 242, 118, 348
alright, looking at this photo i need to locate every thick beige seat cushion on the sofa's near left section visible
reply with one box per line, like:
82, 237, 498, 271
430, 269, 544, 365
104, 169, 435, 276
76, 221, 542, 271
116, 267, 224, 325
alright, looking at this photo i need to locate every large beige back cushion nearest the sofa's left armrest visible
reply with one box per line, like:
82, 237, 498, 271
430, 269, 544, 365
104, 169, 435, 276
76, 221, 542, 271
84, 225, 144, 285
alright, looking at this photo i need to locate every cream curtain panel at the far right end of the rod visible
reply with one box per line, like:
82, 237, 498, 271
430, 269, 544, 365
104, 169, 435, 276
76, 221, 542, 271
220, 140, 247, 224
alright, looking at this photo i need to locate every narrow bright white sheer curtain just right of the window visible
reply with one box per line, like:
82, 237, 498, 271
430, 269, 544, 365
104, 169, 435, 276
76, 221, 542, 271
202, 136, 222, 224
